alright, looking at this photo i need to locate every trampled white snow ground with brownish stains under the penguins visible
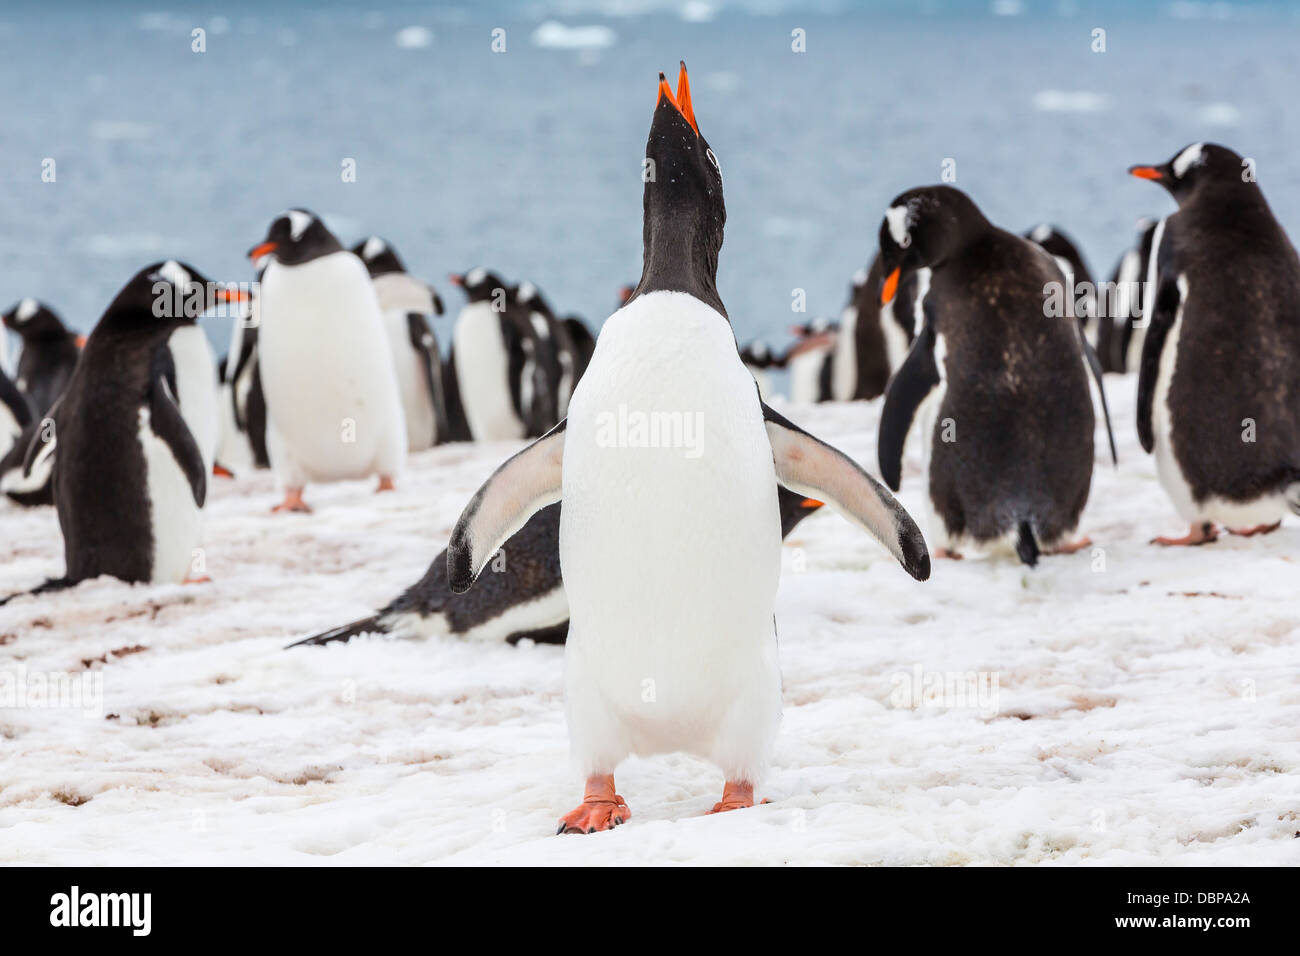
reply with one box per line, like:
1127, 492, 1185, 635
0, 378, 1300, 865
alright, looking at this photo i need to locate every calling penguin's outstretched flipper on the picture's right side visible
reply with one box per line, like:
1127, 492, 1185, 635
763, 405, 930, 581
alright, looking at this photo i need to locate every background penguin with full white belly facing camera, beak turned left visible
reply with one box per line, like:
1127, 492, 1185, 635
248, 209, 407, 511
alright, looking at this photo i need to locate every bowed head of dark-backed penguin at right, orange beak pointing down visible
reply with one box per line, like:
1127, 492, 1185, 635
880, 186, 989, 306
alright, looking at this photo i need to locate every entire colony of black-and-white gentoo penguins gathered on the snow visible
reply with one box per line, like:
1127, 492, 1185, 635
0, 54, 1300, 832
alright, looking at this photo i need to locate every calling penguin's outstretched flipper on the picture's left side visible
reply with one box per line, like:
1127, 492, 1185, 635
447, 421, 566, 594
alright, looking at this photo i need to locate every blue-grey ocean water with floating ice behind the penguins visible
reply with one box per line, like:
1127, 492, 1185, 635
0, 0, 1300, 351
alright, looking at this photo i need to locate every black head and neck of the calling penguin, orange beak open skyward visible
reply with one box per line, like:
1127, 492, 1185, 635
628, 62, 727, 315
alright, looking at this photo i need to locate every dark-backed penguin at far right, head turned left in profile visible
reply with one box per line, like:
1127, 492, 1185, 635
1128, 143, 1300, 545
